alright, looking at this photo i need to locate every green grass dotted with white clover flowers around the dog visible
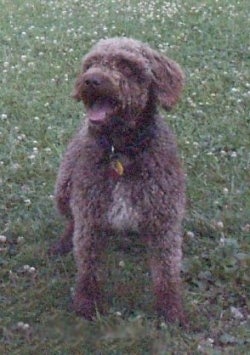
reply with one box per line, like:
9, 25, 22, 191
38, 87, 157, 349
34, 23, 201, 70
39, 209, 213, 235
0, 0, 250, 355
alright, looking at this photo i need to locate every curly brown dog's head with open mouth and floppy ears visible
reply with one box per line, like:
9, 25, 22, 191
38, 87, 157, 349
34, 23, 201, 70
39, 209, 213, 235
73, 38, 184, 129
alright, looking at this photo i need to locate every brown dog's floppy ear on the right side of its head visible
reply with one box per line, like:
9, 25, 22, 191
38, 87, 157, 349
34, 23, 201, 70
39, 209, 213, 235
150, 51, 184, 110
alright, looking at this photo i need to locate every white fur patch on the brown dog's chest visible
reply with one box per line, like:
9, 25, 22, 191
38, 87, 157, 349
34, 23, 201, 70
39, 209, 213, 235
108, 182, 138, 232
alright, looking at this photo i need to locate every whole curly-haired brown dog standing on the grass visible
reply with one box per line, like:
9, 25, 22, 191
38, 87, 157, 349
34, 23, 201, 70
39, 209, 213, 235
52, 38, 186, 324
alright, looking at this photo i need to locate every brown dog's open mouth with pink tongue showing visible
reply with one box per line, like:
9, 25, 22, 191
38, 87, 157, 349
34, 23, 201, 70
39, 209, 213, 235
87, 97, 117, 124
